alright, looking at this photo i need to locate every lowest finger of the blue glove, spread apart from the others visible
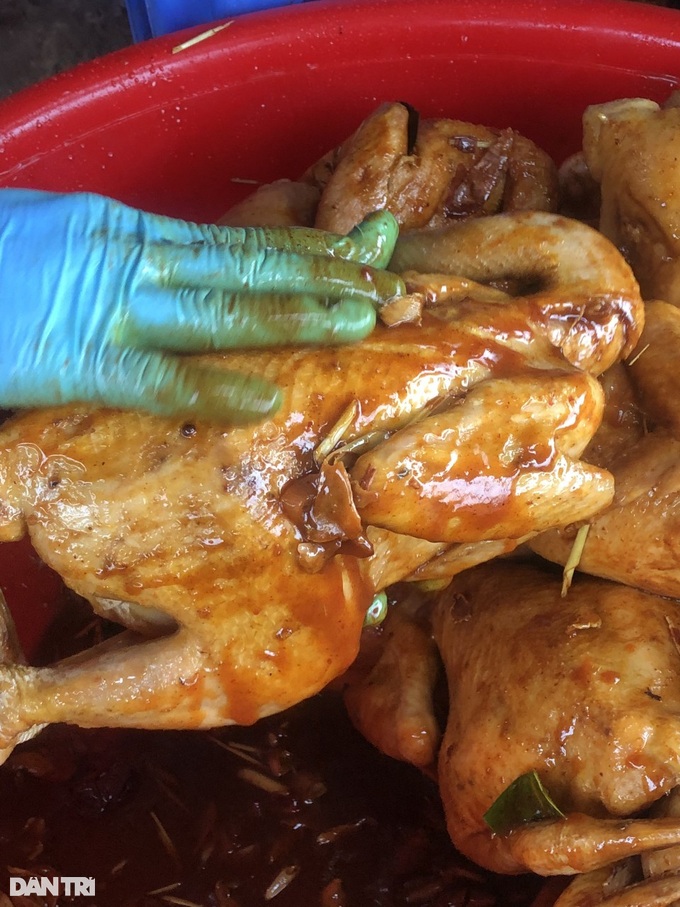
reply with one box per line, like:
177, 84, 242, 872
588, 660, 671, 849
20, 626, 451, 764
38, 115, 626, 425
90, 348, 281, 425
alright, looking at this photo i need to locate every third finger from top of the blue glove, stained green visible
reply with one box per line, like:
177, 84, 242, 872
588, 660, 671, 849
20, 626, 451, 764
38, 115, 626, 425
112, 290, 376, 353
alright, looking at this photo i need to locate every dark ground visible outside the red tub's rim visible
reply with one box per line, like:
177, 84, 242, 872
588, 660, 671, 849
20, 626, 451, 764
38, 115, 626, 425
0, 0, 680, 98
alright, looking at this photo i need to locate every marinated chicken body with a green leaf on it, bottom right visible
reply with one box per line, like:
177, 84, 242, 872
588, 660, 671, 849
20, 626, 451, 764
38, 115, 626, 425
433, 561, 680, 884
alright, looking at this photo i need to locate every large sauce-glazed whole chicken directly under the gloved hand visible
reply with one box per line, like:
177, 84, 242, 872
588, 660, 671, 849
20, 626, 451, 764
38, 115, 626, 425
0, 215, 641, 752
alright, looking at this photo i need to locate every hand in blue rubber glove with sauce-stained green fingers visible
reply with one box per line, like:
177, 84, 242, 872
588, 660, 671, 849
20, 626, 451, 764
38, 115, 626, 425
0, 189, 404, 422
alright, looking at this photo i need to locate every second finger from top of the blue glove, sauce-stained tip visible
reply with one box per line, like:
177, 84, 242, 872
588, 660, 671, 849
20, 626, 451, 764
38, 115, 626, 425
139, 240, 404, 303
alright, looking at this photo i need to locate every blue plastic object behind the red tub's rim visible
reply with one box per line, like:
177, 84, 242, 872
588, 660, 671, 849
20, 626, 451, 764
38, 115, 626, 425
127, 0, 304, 41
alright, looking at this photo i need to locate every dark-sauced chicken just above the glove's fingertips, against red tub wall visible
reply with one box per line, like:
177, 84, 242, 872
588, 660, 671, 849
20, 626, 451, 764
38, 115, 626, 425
302, 103, 558, 233
